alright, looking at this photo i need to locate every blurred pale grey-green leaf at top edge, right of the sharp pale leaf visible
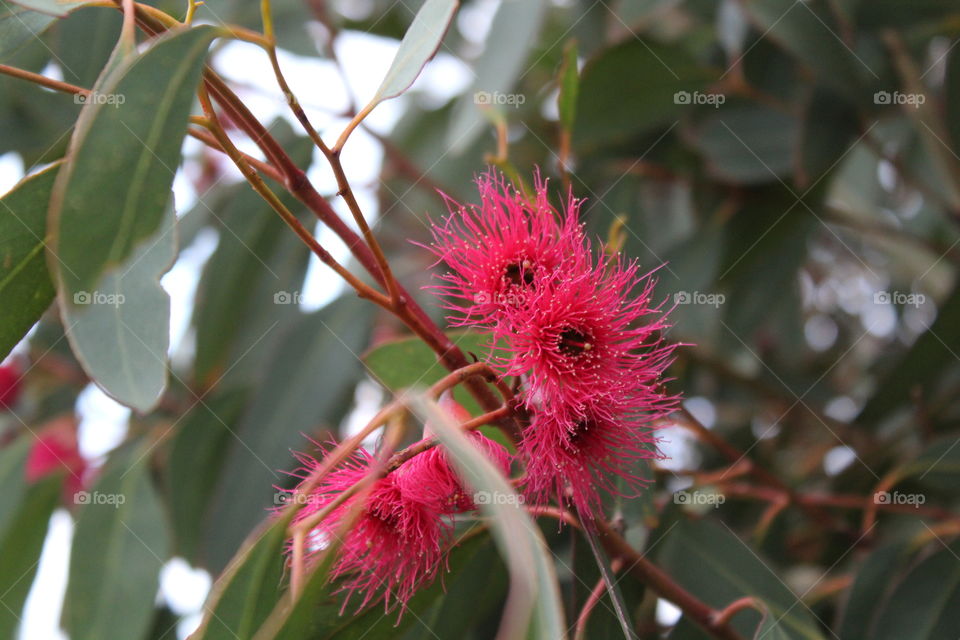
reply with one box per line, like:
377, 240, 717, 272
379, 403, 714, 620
446, 0, 546, 155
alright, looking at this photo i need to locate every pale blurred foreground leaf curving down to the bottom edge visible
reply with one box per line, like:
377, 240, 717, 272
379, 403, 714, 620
413, 398, 566, 640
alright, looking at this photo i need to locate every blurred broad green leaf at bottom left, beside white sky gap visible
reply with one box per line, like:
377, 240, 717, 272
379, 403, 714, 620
64, 444, 170, 640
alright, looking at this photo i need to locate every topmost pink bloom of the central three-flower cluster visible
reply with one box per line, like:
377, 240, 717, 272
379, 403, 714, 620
429, 169, 584, 327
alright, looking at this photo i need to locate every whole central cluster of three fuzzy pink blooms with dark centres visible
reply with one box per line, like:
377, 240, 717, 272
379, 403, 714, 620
430, 171, 676, 516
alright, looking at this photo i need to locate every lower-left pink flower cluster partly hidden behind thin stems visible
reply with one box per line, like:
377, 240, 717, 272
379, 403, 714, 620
284, 397, 511, 613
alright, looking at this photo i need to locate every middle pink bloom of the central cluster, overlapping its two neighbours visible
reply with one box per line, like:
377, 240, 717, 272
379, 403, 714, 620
495, 250, 675, 419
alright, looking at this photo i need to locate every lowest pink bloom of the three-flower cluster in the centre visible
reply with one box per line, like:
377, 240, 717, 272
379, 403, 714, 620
520, 408, 660, 517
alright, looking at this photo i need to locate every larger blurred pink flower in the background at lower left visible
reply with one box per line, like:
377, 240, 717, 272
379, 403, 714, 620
25, 416, 87, 503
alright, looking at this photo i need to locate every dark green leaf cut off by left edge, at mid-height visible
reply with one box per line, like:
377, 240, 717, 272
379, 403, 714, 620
0, 165, 59, 359
